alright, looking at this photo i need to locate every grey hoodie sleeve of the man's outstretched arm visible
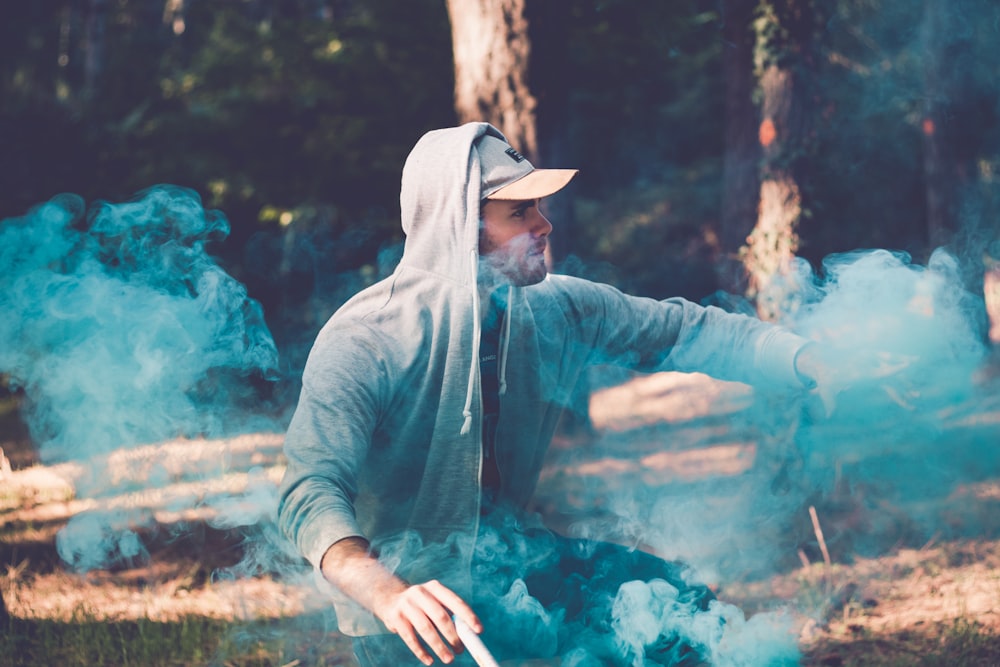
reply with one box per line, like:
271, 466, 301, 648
552, 279, 809, 389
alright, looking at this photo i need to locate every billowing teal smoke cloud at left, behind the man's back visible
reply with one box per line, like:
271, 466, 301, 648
0, 185, 277, 461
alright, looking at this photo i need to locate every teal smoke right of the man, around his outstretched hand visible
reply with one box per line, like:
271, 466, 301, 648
556, 245, 998, 665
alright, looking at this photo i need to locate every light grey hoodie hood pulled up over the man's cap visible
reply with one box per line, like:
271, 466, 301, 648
399, 123, 506, 284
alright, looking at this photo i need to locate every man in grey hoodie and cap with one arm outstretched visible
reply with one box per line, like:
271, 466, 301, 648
279, 123, 810, 665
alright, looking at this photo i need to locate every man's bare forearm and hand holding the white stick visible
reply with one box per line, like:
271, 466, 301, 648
320, 537, 482, 665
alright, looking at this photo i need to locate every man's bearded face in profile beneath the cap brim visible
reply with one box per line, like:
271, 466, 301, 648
479, 199, 552, 287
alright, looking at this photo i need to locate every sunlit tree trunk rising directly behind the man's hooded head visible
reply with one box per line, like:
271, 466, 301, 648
448, 0, 538, 162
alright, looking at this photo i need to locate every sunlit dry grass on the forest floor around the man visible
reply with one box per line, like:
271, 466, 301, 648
0, 375, 1000, 666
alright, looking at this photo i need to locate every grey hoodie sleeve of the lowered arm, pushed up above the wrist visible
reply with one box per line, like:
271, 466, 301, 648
278, 324, 387, 567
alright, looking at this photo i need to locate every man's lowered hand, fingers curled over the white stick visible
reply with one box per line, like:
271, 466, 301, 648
383, 581, 482, 665
